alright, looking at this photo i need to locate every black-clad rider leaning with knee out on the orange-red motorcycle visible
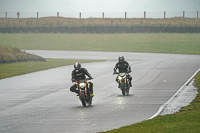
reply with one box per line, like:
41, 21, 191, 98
70, 62, 94, 96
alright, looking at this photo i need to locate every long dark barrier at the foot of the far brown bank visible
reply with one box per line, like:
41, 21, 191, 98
0, 26, 200, 33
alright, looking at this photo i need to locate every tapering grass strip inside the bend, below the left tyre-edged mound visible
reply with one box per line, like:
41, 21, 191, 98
0, 59, 103, 79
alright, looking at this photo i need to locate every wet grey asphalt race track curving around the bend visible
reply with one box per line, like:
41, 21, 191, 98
0, 50, 200, 133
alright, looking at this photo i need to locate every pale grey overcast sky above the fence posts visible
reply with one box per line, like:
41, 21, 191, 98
0, 0, 200, 17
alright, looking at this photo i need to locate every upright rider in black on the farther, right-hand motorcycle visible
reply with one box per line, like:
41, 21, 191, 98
113, 56, 132, 87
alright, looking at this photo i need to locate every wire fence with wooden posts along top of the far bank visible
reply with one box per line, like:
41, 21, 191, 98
0, 11, 200, 19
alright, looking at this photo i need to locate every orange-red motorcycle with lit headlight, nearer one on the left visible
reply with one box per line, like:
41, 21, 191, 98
75, 79, 92, 107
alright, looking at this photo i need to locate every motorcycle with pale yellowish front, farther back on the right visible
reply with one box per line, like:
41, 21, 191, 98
114, 73, 130, 96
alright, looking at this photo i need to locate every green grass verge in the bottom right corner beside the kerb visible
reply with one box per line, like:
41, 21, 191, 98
103, 72, 200, 133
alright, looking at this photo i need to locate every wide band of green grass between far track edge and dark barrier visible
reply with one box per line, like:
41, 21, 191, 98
0, 33, 200, 55
